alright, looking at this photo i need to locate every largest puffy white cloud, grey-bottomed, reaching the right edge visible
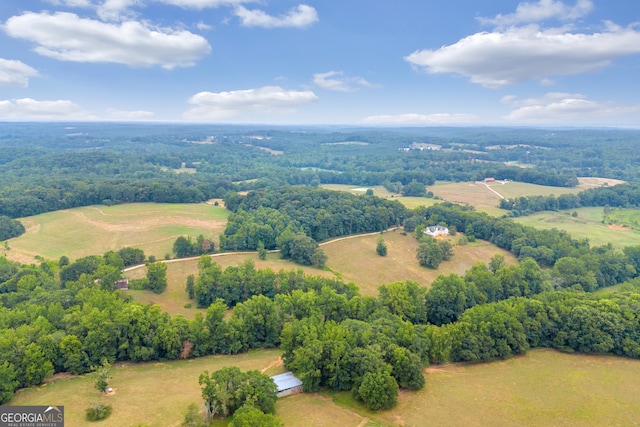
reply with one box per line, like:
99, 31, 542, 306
405, 25, 640, 88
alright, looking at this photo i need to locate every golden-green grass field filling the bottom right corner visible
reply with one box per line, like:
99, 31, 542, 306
364, 350, 640, 426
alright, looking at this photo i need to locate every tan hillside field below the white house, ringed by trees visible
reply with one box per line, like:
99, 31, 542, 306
322, 230, 516, 295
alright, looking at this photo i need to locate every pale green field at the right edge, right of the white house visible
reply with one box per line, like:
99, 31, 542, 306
514, 207, 640, 249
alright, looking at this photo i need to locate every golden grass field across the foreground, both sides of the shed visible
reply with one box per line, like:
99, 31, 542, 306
9, 349, 640, 427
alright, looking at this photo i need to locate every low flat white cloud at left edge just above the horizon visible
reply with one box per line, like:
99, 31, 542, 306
0, 98, 95, 120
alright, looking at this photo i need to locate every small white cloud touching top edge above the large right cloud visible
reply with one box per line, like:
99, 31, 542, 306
478, 0, 593, 27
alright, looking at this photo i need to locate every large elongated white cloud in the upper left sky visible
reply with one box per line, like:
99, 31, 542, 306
4, 12, 211, 69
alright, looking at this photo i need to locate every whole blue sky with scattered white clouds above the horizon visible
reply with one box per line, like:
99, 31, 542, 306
0, 0, 640, 126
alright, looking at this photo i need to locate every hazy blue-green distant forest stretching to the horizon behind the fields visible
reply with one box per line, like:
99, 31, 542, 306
0, 123, 640, 218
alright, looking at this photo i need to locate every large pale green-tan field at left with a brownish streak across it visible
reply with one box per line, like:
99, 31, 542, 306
6, 203, 229, 263
